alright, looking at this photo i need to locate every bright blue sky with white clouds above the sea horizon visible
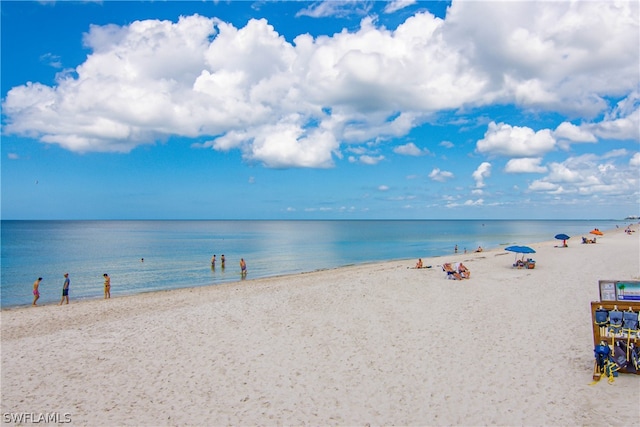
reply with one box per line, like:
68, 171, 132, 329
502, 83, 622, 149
0, 0, 640, 219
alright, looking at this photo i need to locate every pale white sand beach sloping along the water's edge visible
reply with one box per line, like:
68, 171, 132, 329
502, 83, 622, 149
1, 225, 640, 426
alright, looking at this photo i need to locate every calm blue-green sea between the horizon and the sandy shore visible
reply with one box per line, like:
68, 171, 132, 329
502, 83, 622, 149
0, 220, 628, 308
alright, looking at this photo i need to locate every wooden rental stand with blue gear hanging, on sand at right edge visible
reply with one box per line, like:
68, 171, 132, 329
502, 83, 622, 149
591, 280, 640, 380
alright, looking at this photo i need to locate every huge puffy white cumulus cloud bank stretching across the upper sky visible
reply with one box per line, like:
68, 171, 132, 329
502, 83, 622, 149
2, 0, 640, 171
